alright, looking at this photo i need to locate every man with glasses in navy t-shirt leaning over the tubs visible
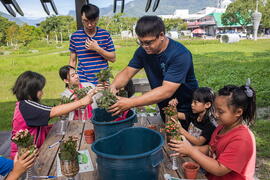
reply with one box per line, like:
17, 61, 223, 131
110, 16, 198, 118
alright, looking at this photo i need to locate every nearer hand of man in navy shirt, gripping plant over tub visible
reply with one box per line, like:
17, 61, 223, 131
108, 97, 132, 116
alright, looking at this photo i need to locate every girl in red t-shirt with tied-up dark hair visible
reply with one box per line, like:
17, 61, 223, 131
169, 83, 256, 180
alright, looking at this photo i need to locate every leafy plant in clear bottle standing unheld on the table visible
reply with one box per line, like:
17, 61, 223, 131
59, 136, 79, 177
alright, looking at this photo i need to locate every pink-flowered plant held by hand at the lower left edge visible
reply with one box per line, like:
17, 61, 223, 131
11, 129, 37, 156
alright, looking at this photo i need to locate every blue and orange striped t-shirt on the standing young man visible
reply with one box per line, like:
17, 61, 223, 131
69, 27, 115, 85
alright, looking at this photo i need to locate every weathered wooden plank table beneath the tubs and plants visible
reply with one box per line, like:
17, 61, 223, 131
33, 113, 206, 180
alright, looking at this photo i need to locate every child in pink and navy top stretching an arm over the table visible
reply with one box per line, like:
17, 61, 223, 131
10, 71, 102, 159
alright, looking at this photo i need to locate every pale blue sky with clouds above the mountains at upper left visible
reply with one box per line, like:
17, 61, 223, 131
0, 0, 132, 19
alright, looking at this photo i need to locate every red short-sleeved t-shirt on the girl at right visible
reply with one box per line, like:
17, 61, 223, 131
207, 125, 256, 180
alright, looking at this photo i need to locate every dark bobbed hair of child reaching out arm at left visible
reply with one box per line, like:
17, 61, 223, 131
12, 71, 46, 102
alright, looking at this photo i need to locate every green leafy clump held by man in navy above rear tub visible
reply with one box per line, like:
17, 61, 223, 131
97, 89, 117, 109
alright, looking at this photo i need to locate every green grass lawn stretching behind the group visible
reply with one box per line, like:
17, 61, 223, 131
0, 39, 270, 176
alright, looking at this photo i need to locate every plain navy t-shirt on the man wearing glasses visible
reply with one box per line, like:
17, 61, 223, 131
128, 39, 198, 115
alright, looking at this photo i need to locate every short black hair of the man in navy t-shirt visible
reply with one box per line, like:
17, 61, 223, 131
135, 16, 165, 37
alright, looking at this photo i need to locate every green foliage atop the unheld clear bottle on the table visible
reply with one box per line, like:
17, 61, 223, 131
59, 136, 79, 161
